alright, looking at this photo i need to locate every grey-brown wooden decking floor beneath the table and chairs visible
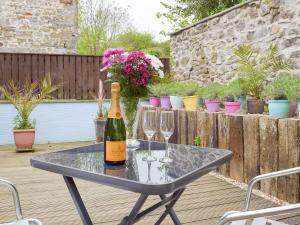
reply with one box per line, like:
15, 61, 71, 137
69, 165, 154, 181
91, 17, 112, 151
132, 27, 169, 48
0, 142, 299, 225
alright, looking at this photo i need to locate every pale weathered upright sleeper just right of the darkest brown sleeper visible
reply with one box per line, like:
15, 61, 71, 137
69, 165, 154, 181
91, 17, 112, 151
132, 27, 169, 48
243, 114, 260, 183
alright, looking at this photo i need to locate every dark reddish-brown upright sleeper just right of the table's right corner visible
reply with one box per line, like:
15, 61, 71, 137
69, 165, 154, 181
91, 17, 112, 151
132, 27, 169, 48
229, 114, 244, 182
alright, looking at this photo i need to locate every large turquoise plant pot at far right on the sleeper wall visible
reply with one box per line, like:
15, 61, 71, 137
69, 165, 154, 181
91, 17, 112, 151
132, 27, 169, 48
269, 100, 291, 118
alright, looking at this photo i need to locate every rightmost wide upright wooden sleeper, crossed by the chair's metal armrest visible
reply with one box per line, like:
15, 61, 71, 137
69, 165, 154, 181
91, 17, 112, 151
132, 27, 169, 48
277, 119, 300, 203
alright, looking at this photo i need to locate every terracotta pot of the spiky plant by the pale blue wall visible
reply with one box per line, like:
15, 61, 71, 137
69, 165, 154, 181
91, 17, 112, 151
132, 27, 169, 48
13, 129, 35, 151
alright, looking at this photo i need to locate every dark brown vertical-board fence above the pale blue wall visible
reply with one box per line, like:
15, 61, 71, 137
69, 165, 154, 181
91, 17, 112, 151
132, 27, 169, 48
0, 53, 170, 99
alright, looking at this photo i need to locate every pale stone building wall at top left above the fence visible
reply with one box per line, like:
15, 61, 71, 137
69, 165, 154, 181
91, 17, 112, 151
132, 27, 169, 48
0, 0, 78, 54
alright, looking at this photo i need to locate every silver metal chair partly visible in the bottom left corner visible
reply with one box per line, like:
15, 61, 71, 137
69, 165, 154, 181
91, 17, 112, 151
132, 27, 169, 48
0, 179, 42, 225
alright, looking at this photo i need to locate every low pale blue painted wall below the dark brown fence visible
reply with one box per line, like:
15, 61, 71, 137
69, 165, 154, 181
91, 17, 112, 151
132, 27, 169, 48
0, 102, 105, 145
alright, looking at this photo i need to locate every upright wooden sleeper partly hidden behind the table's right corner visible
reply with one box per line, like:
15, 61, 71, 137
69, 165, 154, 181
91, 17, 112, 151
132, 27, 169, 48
218, 113, 230, 176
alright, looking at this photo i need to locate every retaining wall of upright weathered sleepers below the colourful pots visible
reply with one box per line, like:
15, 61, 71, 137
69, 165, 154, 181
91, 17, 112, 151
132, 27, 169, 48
138, 109, 300, 202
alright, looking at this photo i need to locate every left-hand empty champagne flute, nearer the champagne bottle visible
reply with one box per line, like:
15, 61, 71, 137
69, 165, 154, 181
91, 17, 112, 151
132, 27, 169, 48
143, 110, 156, 162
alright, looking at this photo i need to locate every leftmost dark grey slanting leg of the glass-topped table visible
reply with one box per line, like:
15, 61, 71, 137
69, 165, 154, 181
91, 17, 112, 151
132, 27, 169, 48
63, 176, 93, 225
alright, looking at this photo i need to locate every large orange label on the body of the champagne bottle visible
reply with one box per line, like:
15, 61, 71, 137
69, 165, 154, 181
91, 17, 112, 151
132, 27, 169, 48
106, 141, 126, 162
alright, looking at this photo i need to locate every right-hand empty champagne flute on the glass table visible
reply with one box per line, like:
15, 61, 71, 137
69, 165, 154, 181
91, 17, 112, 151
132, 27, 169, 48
159, 111, 174, 163
